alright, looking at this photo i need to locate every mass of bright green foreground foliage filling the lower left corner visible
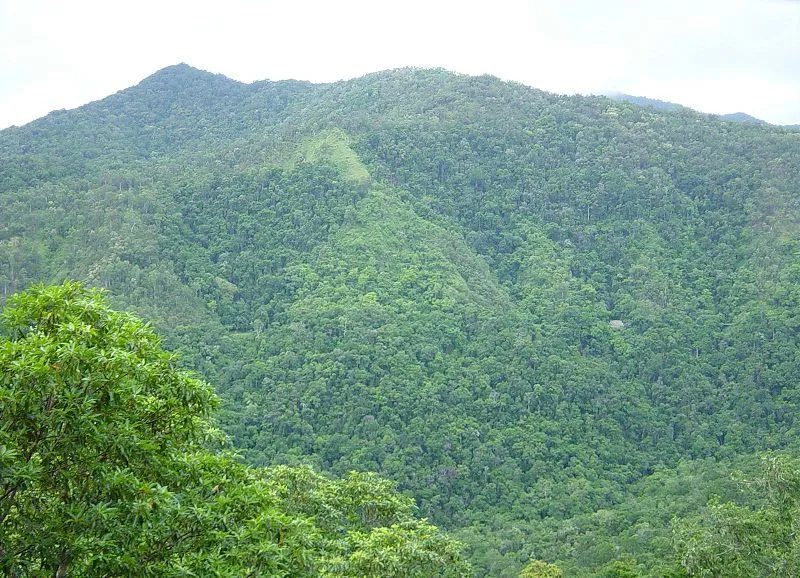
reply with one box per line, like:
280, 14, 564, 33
0, 283, 469, 577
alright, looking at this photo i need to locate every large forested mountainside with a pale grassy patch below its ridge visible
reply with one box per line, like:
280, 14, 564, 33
0, 65, 800, 576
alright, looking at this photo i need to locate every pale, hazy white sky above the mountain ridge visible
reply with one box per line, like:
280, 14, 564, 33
0, 0, 800, 128
